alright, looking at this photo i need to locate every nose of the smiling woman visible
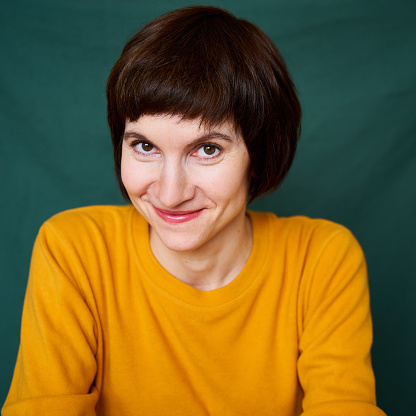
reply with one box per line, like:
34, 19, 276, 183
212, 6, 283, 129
155, 161, 195, 209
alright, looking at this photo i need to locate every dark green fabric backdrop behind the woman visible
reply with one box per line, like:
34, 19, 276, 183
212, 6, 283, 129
0, 0, 416, 416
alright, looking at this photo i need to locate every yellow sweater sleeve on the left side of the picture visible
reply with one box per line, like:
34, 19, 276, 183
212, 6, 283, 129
2, 223, 98, 416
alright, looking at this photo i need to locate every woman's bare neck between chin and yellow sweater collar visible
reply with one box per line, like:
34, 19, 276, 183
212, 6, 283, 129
150, 216, 253, 291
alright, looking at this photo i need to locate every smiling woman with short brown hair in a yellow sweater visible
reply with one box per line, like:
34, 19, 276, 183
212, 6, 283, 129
2, 6, 384, 416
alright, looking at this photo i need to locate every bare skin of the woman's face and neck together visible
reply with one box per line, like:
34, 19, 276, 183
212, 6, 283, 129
121, 115, 252, 290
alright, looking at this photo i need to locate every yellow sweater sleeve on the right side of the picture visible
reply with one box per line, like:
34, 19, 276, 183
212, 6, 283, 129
298, 228, 385, 416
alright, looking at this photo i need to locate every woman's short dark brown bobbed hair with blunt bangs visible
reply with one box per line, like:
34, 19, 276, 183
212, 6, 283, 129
107, 6, 301, 201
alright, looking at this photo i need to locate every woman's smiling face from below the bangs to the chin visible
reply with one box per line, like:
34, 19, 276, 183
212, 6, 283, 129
121, 115, 250, 255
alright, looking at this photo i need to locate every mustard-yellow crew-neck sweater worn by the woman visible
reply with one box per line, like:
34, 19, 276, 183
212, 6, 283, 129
2, 206, 384, 416
